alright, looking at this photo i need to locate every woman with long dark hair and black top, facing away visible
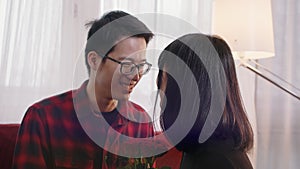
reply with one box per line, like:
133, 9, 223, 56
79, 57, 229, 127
157, 34, 253, 169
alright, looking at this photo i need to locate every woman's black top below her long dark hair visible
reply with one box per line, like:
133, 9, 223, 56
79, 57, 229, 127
180, 139, 253, 169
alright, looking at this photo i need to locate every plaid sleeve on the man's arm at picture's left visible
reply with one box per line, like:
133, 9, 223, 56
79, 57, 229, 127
13, 107, 50, 169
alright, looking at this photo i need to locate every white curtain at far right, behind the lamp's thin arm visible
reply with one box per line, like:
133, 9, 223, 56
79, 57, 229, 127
255, 0, 300, 169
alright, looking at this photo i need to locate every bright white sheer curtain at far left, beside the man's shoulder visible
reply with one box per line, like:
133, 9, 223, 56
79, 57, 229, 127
0, 0, 63, 123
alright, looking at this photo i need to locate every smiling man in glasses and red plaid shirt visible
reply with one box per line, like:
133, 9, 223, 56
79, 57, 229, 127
13, 11, 153, 169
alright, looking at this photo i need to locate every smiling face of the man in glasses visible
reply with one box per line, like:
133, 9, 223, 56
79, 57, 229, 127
95, 37, 146, 100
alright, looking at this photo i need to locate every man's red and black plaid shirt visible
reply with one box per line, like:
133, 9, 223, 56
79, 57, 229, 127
13, 82, 153, 169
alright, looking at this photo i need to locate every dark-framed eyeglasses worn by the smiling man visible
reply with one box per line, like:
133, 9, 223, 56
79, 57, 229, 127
104, 55, 152, 75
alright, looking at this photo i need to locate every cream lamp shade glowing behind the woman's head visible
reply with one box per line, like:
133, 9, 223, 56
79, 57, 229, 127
212, 0, 274, 59
